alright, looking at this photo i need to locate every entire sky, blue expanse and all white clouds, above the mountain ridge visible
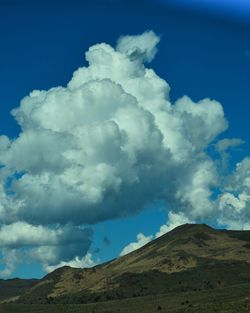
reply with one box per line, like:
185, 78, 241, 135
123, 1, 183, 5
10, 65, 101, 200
0, 0, 250, 278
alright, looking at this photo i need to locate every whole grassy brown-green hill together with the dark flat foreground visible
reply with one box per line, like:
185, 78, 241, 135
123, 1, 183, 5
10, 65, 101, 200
0, 224, 250, 313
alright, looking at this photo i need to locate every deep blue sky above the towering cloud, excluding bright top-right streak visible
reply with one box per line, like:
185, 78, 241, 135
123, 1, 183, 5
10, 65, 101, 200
0, 0, 250, 147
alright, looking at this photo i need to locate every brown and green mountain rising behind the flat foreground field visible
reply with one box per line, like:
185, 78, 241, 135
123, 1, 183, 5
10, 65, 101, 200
13, 224, 250, 306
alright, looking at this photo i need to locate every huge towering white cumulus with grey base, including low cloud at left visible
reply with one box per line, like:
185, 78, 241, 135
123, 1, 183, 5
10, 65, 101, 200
0, 31, 250, 276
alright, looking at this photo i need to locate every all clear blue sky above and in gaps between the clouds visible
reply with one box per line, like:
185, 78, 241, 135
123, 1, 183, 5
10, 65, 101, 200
0, 0, 250, 277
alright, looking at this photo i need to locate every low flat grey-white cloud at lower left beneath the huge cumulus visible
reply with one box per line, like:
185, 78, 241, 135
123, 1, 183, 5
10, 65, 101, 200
0, 222, 92, 276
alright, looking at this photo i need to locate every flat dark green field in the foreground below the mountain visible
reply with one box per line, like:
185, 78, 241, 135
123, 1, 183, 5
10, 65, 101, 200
0, 283, 250, 313
